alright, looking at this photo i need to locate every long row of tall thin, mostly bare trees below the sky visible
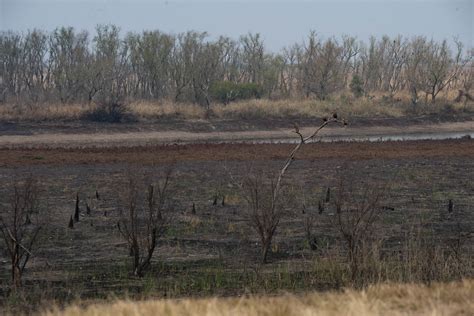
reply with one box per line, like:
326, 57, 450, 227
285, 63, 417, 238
0, 25, 474, 106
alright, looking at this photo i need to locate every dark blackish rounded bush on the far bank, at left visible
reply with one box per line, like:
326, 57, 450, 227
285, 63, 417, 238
82, 102, 135, 123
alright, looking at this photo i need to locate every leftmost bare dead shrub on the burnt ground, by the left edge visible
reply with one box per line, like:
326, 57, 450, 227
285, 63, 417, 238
0, 176, 42, 289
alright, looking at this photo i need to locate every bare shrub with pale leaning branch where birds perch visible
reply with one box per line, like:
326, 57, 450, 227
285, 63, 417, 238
242, 113, 347, 263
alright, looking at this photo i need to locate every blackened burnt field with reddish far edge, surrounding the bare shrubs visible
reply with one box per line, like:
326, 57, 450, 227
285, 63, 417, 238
0, 140, 474, 312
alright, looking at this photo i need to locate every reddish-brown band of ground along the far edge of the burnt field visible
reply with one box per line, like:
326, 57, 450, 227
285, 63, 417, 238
0, 139, 474, 169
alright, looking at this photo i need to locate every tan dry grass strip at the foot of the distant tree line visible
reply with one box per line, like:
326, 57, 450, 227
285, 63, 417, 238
0, 94, 474, 121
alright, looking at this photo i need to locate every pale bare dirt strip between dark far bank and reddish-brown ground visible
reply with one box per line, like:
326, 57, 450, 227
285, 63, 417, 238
0, 121, 474, 148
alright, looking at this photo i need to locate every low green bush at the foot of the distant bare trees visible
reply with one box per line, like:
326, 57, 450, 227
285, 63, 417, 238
211, 81, 262, 104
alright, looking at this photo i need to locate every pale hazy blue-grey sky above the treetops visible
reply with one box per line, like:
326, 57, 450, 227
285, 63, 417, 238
0, 0, 474, 51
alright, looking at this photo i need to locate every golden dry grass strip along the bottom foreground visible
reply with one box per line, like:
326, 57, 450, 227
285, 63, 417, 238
43, 280, 474, 316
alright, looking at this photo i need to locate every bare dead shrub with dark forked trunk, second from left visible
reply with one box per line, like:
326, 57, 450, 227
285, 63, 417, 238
117, 169, 172, 277
